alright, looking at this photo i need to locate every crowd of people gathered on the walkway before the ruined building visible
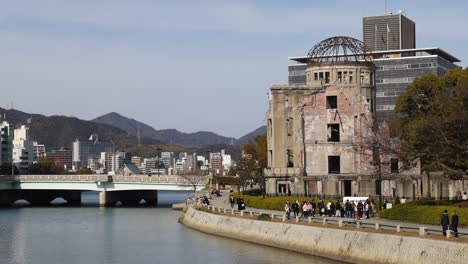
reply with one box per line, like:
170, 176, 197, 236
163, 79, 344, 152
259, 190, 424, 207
284, 199, 375, 220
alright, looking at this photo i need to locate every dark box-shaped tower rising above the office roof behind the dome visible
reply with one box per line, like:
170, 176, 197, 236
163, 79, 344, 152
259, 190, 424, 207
362, 12, 416, 51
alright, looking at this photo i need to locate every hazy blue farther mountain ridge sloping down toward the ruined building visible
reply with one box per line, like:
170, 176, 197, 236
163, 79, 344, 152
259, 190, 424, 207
92, 112, 266, 147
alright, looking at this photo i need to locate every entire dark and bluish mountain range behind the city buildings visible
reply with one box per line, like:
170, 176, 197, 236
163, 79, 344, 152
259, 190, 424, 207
0, 108, 266, 154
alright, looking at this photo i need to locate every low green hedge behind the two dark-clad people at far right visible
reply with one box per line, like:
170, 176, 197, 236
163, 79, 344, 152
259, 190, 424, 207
379, 201, 468, 225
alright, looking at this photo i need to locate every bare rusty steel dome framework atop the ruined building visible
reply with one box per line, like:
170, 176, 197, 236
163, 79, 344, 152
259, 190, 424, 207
307, 36, 371, 63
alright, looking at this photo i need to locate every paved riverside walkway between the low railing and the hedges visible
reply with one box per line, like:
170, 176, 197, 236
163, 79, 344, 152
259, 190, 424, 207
210, 190, 468, 234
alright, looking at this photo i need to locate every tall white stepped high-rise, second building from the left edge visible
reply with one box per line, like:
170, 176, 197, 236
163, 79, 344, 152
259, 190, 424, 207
13, 125, 34, 173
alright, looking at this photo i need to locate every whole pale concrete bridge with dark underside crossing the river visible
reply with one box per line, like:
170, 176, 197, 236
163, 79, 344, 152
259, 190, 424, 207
0, 175, 208, 206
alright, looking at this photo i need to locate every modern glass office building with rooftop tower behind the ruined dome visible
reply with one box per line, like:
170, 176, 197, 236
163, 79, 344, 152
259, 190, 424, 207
288, 13, 460, 119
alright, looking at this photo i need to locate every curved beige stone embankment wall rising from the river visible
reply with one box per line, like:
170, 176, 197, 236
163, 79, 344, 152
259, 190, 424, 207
181, 207, 468, 264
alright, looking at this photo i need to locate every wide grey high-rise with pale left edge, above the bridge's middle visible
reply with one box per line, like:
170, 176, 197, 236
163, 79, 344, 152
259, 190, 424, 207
72, 136, 114, 169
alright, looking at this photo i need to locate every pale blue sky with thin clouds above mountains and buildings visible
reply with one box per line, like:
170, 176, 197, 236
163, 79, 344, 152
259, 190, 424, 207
0, 0, 468, 138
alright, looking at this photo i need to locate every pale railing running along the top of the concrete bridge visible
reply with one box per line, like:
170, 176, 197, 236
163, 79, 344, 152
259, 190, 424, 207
0, 175, 208, 185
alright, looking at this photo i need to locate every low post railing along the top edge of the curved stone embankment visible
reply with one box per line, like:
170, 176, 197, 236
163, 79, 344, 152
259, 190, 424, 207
200, 204, 468, 238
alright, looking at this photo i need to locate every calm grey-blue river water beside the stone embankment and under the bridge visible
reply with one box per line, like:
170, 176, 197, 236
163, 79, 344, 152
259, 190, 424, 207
0, 192, 337, 264
